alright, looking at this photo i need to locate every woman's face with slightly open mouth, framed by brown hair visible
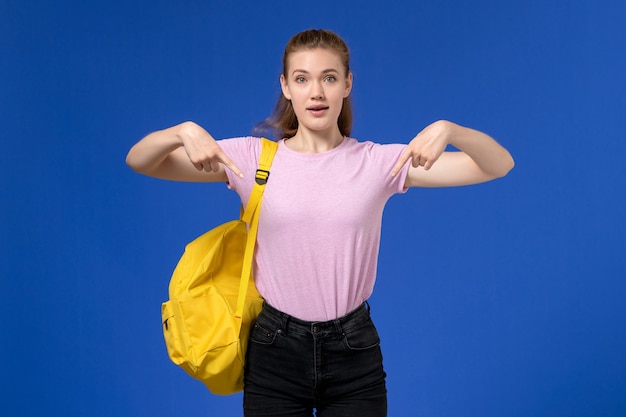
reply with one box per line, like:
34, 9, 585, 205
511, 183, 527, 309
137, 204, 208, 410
280, 48, 352, 134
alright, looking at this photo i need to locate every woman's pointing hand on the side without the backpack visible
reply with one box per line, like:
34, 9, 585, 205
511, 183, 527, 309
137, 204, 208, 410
391, 120, 451, 177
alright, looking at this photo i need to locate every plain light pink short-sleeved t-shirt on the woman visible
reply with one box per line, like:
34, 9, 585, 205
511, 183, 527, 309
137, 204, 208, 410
219, 137, 409, 321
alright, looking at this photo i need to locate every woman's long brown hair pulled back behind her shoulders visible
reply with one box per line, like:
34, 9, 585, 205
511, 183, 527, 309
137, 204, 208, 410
254, 29, 352, 139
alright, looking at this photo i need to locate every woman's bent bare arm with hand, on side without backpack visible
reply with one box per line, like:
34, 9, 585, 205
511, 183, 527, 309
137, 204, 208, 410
392, 120, 514, 187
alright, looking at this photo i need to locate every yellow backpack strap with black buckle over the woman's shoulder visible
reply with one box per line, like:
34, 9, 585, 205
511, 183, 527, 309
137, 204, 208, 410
235, 138, 278, 320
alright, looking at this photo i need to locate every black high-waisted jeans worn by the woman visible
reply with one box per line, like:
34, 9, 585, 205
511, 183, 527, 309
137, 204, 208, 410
243, 304, 387, 417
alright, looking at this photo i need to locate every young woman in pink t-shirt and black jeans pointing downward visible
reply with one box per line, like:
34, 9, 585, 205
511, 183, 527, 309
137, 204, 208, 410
127, 30, 513, 417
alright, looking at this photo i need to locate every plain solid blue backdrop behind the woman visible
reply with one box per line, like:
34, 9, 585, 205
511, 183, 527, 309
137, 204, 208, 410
0, 0, 626, 417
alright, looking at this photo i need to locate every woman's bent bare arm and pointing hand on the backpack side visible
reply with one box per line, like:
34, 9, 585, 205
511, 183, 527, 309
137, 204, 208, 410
126, 118, 242, 182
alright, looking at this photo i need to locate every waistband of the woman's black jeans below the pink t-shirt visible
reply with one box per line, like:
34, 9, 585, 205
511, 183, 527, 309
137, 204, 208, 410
261, 301, 370, 335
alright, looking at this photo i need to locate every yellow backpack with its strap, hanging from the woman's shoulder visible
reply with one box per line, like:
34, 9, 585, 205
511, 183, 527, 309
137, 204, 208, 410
161, 138, 278, 395
